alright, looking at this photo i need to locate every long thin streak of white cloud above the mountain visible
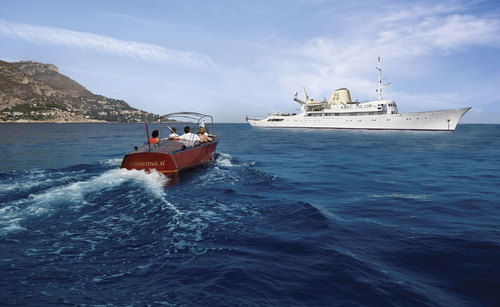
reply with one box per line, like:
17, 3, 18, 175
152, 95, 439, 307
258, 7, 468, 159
0, 20, 220, 71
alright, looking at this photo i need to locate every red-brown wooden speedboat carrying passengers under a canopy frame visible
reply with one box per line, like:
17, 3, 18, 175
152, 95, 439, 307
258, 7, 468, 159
121, 112, 219, 176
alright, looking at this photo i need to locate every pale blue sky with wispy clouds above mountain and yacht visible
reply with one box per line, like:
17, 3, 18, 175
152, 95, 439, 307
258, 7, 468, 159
0, 0, 500, 123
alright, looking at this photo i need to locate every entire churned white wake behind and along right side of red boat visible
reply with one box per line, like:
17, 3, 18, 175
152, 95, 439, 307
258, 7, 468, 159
0, 153, 273, 236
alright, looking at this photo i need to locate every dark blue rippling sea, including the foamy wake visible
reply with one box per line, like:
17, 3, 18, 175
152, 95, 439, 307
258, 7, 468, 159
0, 124, 500, 306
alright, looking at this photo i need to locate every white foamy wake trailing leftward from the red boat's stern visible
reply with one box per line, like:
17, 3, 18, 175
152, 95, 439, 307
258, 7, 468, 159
0, 169, 180, 235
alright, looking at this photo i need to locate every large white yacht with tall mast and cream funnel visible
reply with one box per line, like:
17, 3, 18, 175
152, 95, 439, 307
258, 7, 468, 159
247, 57, 470, 131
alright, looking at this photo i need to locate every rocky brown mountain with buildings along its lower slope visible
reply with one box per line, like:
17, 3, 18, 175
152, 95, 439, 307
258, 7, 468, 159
0, 61, 160, 122
